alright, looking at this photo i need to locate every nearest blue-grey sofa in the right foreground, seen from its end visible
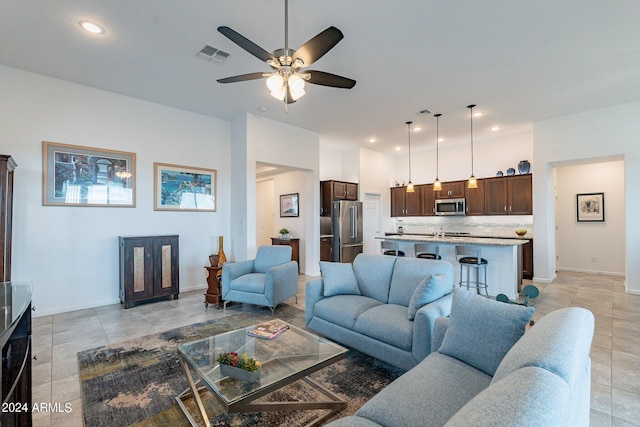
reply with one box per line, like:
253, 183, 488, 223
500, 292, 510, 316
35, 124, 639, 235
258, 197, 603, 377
328, 289, 594, 427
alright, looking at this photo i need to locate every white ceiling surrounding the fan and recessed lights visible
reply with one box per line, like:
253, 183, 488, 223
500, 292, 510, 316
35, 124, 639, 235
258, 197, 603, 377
0, 0, 640, 152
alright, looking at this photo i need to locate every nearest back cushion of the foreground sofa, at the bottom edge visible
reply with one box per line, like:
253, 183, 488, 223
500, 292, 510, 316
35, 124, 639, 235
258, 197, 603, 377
445, 366, 568, 427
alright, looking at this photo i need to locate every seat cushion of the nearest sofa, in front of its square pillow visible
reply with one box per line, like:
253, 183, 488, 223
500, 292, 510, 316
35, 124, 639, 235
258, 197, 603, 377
356, 352, 491, 427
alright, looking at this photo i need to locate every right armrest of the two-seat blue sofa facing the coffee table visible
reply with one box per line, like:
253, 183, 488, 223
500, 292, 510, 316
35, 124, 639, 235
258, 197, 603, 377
411, 293, 453, 362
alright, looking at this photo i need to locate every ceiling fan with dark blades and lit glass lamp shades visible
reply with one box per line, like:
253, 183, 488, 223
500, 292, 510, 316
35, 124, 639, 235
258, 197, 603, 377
218, 0, 356, 110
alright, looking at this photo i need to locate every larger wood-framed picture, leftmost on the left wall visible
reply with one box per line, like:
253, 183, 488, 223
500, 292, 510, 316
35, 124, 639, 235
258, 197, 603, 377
42, 141, 136, 207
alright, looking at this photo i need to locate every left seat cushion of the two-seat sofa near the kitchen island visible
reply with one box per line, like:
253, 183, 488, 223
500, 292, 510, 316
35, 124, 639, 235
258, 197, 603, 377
313, 295, 382, 329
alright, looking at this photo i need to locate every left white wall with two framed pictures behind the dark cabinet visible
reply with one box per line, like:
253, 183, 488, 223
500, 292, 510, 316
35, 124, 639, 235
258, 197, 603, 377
0, 66, 230, 316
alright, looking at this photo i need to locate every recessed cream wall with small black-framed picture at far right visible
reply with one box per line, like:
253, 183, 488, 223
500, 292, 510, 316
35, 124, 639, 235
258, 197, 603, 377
556, 160, 625, 275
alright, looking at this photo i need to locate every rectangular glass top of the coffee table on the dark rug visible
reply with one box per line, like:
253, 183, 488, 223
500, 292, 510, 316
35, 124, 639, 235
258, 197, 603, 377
178, 321, 347, 405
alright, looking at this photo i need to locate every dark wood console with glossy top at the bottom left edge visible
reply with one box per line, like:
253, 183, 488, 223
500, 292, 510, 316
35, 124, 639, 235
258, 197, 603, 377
0, 282, 33, 426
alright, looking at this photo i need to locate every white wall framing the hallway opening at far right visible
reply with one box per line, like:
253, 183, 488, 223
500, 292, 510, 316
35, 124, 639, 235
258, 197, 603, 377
532, 102, 640, 294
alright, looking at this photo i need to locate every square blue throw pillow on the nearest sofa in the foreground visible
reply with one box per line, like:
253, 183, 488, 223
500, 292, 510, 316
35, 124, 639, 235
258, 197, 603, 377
438, 288, 534, 376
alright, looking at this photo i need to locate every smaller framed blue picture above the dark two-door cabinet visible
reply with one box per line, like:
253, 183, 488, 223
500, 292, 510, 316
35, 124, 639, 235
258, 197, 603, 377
153, 163, 217, 212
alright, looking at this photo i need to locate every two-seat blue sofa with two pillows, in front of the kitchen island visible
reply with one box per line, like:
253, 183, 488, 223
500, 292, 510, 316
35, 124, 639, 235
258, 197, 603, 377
305, 254, 453, 370
